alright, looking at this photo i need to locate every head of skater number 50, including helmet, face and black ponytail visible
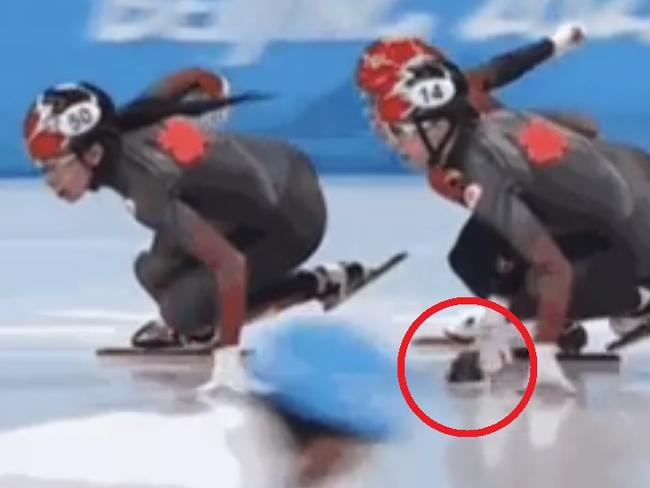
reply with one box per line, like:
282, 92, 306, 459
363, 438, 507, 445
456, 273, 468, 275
23, 82, 267, 202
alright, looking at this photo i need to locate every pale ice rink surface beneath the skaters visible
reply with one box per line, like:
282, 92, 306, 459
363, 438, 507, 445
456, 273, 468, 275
0, 177, 650, 488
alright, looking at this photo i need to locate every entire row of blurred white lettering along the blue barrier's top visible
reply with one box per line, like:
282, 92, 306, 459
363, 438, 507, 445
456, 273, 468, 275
90, 0, 650, 64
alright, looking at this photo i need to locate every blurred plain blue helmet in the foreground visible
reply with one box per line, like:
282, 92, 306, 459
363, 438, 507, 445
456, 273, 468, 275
249, 319, 404, 440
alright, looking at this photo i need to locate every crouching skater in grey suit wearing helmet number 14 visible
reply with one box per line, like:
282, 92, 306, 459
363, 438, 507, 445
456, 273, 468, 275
356, 38, 650, 391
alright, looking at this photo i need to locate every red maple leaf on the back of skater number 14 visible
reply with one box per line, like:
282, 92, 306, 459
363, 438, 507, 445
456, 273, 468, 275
519, 120, 567, 166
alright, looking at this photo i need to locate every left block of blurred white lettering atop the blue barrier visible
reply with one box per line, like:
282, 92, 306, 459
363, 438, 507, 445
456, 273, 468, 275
90, 0, 435, 61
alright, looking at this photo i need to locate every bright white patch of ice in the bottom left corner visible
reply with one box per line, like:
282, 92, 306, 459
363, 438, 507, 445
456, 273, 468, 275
0, 405, 244, 488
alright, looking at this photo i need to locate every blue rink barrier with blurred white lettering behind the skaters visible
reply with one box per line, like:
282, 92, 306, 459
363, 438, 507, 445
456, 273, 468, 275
0, 0, 650, 176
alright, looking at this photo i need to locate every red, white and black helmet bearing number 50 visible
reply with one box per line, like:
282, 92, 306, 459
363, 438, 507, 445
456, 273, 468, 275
23, 82, 115, 164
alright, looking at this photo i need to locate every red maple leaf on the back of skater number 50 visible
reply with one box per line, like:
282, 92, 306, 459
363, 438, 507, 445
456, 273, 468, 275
158, 119, 208, 167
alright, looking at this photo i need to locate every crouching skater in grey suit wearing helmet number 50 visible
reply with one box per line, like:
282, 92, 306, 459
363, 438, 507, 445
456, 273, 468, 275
24, 83, 363, 392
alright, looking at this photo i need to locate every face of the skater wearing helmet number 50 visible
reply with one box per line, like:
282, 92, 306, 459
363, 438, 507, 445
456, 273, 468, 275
42, 145, 103, 203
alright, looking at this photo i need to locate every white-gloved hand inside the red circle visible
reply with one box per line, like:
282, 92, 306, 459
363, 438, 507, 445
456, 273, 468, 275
476, 310, 516, 375
